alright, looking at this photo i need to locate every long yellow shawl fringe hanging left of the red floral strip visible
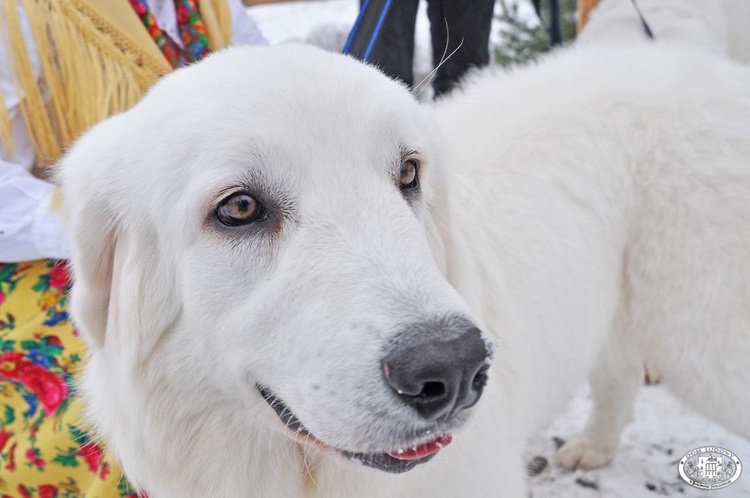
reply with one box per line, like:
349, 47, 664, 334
3, 0, 160, 167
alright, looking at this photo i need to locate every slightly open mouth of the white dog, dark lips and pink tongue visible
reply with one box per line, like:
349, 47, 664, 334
256, 385, 452, 474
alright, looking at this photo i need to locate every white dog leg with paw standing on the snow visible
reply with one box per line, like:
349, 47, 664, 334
556, 320, 643, 469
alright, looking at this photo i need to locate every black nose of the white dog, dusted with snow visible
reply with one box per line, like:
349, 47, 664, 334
383, 320, 491, 420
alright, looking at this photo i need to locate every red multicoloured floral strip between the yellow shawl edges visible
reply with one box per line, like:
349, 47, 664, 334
130, 0, 209, 68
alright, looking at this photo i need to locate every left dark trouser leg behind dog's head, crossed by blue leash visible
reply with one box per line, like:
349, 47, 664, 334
345, 0, 419, 87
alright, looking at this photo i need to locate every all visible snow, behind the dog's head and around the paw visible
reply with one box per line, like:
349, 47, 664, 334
248, 0, 750, 498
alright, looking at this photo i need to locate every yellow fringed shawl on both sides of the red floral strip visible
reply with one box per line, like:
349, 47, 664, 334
0, 0, 232, 167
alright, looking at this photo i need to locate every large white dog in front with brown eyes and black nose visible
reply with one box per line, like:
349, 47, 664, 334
61, 37, 750, 498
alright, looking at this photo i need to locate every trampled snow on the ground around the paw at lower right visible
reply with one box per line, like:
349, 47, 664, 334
527, 385, 750, 498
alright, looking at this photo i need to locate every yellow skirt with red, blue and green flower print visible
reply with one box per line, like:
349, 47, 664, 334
0, 260, 138, 498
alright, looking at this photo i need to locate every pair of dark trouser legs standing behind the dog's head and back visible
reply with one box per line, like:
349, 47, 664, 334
347, 0, 495, 97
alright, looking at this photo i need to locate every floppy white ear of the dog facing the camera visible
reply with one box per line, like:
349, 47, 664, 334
57, 116, 180, 358
